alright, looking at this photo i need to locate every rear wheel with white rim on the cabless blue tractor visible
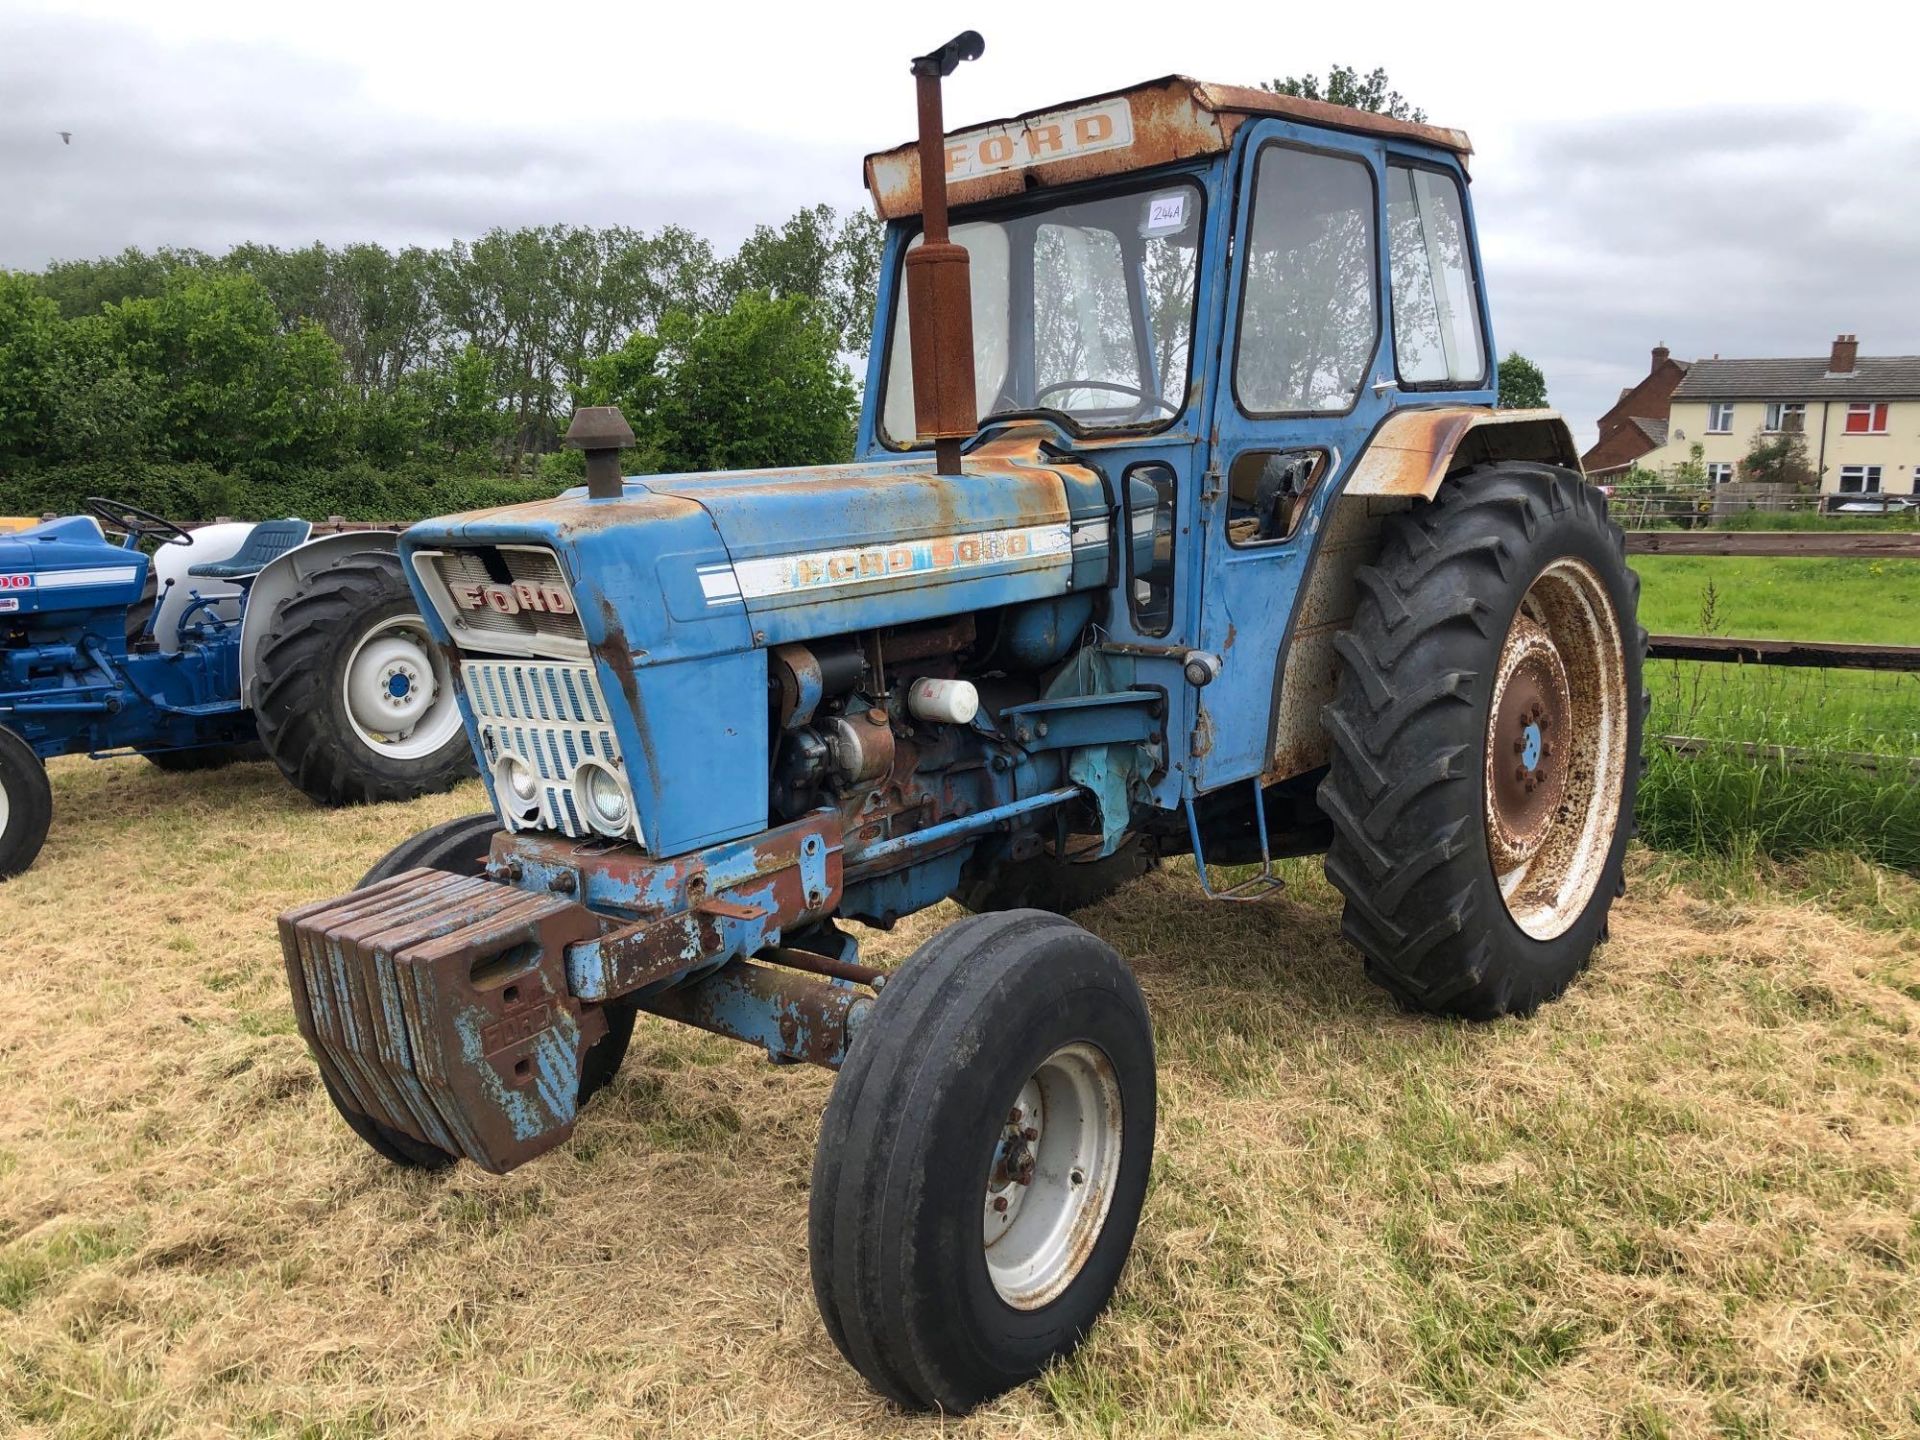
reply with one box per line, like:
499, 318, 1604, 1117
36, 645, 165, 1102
253, 551, 474, 804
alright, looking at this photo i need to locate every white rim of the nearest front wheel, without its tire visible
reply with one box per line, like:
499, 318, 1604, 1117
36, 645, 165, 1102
983, 1043, 1123, 1309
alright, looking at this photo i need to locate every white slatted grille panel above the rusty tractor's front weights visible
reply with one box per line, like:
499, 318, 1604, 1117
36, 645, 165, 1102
461, 660, 626, 837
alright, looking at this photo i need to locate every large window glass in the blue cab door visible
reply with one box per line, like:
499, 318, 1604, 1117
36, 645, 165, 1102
1233, 144, 1379, 415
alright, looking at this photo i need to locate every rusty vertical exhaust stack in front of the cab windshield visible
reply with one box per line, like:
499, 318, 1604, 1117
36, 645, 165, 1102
906, 31, 987, 474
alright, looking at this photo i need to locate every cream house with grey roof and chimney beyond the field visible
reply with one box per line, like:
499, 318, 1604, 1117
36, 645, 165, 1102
1620, 334, 1920, 495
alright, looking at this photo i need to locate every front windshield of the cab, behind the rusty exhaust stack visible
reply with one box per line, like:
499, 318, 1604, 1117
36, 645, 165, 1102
881, 180, 1200, 445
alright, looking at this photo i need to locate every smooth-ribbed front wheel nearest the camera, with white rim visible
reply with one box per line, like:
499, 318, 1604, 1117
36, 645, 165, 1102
808, 910, 1154, 1413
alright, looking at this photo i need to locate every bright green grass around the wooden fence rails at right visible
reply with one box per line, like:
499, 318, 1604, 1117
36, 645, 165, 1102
1634, 557, 1920, 870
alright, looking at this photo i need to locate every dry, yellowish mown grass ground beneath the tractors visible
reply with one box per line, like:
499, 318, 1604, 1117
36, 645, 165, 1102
0, 760, 1920, 1440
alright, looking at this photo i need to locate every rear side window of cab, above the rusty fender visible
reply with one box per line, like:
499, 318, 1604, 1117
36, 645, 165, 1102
1386, 163, 1486, 388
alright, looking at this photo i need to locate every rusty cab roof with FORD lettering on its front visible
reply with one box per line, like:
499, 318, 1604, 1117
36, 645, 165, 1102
866, 75, 1473, 221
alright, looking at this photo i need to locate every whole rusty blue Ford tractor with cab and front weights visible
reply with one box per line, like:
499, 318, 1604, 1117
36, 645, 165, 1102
280, 35, 1644, 1411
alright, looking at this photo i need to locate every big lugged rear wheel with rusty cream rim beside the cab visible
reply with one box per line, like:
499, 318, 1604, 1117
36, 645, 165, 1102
1319, 463, 1647, 1020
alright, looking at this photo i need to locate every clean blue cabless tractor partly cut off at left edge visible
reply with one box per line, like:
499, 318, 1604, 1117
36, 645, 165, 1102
0, 499, 472, 879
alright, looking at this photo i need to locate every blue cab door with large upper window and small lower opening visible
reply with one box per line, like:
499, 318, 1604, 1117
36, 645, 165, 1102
1192, 121, 1396, 791
